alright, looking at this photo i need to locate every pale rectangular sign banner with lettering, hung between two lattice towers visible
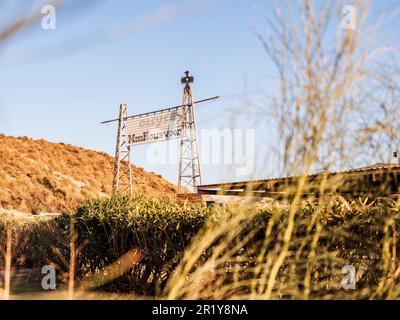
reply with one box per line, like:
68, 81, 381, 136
125, 107, 183, 146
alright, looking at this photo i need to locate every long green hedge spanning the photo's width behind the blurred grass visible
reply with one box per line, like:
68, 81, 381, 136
0, 196, 400, 298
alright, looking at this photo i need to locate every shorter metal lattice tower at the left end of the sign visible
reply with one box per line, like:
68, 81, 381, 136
113, 104, 132, 195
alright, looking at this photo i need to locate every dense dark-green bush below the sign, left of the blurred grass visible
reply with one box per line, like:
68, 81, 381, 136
58, 192, 211, 295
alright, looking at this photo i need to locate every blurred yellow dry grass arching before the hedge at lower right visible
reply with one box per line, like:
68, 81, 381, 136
164, 199, 400, 300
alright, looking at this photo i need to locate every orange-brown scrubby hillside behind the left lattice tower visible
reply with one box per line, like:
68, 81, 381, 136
0, 135, 176, 213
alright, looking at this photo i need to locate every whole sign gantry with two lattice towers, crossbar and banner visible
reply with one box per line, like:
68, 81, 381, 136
101, 71, 219, 195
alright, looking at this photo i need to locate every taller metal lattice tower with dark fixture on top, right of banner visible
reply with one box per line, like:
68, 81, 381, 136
178, 71, 203, 193
